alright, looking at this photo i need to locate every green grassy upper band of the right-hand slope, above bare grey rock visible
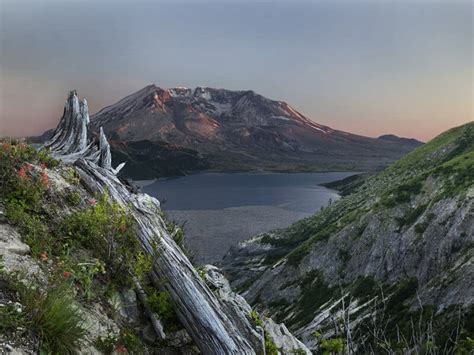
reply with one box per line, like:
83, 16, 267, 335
264, 123, 474, 263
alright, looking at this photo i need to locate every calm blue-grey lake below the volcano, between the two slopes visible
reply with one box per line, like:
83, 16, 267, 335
142, 172, 354, 264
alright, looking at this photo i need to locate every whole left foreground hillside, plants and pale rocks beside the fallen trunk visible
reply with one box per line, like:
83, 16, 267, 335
0, 141, 189, 354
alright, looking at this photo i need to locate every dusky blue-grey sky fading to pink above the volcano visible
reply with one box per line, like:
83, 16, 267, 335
0, 0, 474, 141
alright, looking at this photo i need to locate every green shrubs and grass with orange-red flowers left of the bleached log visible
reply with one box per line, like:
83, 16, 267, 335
0, 141, 179, 354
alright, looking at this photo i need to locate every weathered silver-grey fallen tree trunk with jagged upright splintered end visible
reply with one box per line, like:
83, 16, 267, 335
46, 91, 262, 354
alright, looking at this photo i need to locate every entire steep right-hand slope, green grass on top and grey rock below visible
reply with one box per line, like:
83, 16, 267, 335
223, 122, 474, 353
